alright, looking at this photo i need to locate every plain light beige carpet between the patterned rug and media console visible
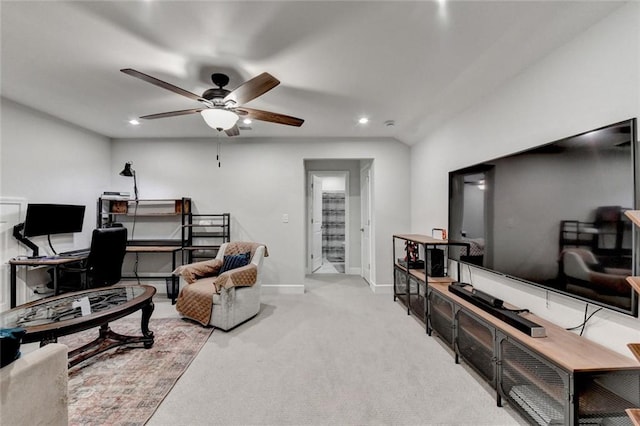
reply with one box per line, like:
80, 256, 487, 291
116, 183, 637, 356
149, 274, 526, 426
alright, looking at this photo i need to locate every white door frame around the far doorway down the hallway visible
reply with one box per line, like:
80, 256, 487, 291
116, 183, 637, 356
305, 170, 351, 274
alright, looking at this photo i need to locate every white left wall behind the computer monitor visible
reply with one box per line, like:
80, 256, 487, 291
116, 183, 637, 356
0, 98, 111, 253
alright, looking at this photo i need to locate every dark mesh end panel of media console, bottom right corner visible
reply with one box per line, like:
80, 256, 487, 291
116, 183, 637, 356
574, 371, 640, 426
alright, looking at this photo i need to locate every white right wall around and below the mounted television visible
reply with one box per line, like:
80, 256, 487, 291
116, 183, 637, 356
411, 2, 640, 356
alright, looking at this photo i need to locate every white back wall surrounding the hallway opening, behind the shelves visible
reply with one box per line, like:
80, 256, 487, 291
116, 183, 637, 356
109, 137, 410, 292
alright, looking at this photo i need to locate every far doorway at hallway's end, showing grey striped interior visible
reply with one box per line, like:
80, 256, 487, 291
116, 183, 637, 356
307, 171, 349, 274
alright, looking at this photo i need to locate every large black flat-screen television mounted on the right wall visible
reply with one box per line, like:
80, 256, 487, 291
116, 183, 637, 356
449, 118, 640, 316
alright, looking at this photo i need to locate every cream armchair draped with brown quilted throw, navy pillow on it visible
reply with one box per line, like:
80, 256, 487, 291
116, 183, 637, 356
173, 242, 268, 331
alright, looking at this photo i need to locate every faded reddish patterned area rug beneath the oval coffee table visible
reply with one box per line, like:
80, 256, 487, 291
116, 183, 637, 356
58, 318, 213, 426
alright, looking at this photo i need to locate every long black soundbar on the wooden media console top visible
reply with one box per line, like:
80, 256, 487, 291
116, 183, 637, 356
449, 283, 547, 337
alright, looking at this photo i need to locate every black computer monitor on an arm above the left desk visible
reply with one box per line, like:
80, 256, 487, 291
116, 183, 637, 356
24, 204, 85, 237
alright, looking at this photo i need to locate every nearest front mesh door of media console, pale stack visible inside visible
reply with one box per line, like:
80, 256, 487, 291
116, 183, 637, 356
498, 334, 574, 425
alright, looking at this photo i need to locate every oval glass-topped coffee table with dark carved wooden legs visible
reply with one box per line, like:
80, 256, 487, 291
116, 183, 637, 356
0, 285, 156, 367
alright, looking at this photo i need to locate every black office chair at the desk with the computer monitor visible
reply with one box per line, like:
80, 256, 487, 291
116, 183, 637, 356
60, 228, 127, 290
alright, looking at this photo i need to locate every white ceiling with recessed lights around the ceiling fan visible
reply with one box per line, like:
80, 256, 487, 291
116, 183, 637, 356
0, 0, 621, 144
